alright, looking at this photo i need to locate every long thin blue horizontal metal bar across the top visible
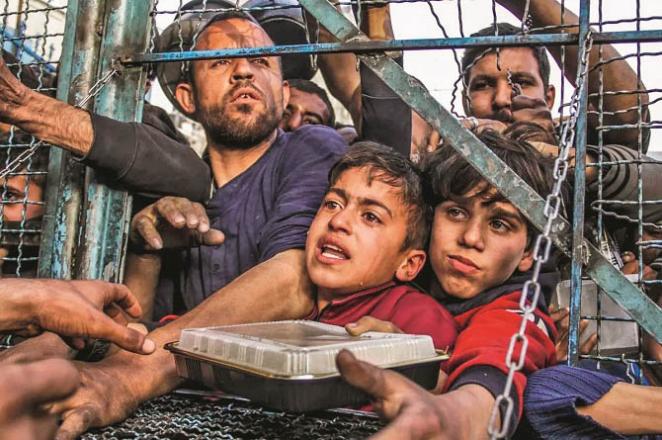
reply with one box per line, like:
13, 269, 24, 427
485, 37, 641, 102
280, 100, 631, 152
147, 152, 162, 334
120, 30, 662, 66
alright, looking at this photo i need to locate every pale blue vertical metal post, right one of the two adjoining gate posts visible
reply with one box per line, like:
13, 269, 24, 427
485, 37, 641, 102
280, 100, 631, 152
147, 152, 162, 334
75, 0, 152, 282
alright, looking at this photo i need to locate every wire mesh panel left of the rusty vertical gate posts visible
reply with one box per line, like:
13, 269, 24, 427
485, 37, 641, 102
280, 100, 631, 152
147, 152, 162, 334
0, 0, 67, 277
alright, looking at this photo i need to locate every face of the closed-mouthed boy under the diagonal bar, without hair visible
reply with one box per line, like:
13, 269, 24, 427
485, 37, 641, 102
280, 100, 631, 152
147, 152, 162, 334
429, 183, 533, 299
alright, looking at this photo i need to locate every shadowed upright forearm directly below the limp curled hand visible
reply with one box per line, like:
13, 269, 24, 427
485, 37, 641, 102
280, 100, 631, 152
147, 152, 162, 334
124, 253, 161, 320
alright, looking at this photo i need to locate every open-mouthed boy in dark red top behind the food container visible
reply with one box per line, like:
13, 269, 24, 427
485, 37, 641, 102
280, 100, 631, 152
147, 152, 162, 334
306, 142, 457, 349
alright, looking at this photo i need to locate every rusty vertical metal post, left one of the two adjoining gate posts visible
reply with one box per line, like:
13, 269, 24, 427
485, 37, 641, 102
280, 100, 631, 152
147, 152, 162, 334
38, 0, 105, 279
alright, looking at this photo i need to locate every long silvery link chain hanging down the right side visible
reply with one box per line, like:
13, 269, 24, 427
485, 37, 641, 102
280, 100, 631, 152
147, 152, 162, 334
487, 30, 593, 439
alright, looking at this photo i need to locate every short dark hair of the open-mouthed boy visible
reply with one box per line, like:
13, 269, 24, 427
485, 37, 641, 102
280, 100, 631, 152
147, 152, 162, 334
329, 141, 432, 250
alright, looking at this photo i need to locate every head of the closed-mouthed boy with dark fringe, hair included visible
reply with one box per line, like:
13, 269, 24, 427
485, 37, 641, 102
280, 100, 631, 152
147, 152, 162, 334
425, 130, 553, 299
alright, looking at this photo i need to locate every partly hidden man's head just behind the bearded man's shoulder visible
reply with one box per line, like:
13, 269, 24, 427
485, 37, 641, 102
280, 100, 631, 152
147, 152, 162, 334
280, 79, 336, 131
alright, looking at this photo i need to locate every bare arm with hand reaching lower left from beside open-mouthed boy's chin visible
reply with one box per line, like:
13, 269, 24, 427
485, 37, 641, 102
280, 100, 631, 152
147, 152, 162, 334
54, 250, 312, 439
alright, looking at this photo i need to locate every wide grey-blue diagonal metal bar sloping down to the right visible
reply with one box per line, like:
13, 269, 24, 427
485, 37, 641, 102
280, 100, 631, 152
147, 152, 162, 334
300, 0, 662, 342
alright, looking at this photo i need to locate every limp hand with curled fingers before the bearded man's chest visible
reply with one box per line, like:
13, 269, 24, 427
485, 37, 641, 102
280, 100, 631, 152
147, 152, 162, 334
130, 197, 225, 251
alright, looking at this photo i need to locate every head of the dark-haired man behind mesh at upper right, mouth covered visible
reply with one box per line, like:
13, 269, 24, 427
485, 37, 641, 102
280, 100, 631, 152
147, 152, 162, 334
461, 23, 556, 123
